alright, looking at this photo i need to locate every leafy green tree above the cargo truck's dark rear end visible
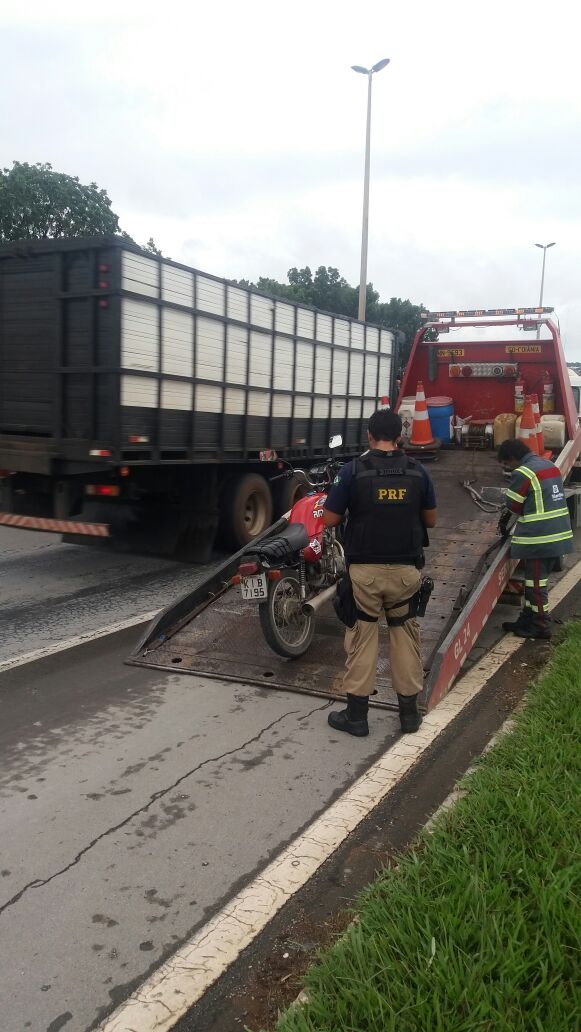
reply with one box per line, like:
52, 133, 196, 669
0, 161, 120, 241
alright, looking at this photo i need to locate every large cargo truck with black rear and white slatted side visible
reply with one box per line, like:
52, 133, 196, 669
0, 238, 394, 560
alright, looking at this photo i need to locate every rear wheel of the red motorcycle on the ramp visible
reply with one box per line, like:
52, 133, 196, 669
258, 574, 315, 659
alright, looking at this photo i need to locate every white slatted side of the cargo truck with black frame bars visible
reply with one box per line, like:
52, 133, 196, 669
121, 252, 394, 452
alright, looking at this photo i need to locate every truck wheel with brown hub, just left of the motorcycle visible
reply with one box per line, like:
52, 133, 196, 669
220, 473, 272, 551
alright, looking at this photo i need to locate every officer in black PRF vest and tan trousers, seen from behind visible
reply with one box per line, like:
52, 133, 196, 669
324, 409, 437, 737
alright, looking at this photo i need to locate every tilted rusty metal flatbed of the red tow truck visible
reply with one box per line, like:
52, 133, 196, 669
127, 449, 503, 707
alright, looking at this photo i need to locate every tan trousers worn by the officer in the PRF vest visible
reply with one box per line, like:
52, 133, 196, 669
343, 563, 423, 696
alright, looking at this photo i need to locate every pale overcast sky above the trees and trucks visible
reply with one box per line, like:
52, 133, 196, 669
0, 0, 581, 360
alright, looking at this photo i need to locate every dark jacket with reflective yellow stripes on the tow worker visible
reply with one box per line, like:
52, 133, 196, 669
507, 452, 573, 559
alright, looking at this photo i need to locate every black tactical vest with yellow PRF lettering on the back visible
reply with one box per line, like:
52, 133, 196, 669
345, 452, 425, 568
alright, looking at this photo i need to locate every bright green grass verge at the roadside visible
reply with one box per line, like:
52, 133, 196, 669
268, 623, 581, 1032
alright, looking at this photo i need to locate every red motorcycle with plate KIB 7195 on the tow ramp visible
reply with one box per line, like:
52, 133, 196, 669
233, 437, 346, 659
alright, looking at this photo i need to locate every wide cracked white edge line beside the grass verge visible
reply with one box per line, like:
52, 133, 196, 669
99, 561, 581, 1032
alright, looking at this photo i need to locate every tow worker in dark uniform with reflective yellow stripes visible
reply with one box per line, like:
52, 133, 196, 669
497, 440, 573, 638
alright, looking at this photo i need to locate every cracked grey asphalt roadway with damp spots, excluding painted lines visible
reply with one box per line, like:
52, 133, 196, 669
0, 531, 396, 1032
